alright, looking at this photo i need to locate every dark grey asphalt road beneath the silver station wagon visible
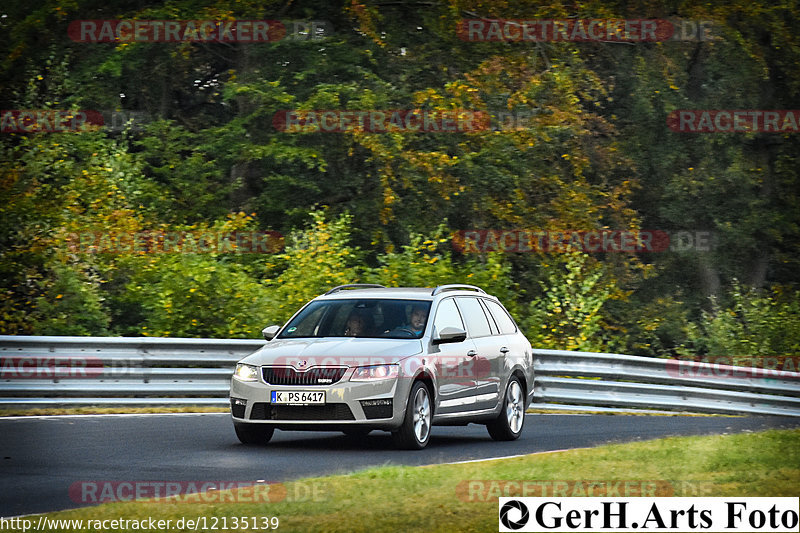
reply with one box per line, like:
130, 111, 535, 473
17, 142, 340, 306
0, 414, 800, 517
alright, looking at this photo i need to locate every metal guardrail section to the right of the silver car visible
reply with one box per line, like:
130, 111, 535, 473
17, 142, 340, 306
534, 350, 800, 416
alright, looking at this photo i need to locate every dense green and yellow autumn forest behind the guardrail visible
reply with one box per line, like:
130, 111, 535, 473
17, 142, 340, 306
0, 0, 800, 358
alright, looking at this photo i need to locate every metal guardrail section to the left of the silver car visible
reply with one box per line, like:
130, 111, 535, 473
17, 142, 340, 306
0, 335, 264, 408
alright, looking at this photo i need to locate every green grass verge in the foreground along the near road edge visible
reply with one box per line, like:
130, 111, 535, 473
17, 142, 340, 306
15, 430, 800, 533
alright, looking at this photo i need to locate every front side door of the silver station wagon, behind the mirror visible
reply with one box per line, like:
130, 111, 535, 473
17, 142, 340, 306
430, 298, 475, 414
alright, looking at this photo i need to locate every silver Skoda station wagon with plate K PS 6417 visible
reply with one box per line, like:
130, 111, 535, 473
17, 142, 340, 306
230, 284, 533, 449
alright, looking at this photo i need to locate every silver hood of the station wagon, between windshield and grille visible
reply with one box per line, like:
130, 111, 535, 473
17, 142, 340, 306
241, 337, 422, 367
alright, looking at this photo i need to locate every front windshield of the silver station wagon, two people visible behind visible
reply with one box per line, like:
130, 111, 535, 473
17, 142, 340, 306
278, 298, 431, 339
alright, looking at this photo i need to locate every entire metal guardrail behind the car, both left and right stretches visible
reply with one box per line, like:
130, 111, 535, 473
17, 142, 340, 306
0, 335, 800, 416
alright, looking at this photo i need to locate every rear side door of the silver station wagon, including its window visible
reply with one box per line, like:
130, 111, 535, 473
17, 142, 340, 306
456, 296, 503, 410
